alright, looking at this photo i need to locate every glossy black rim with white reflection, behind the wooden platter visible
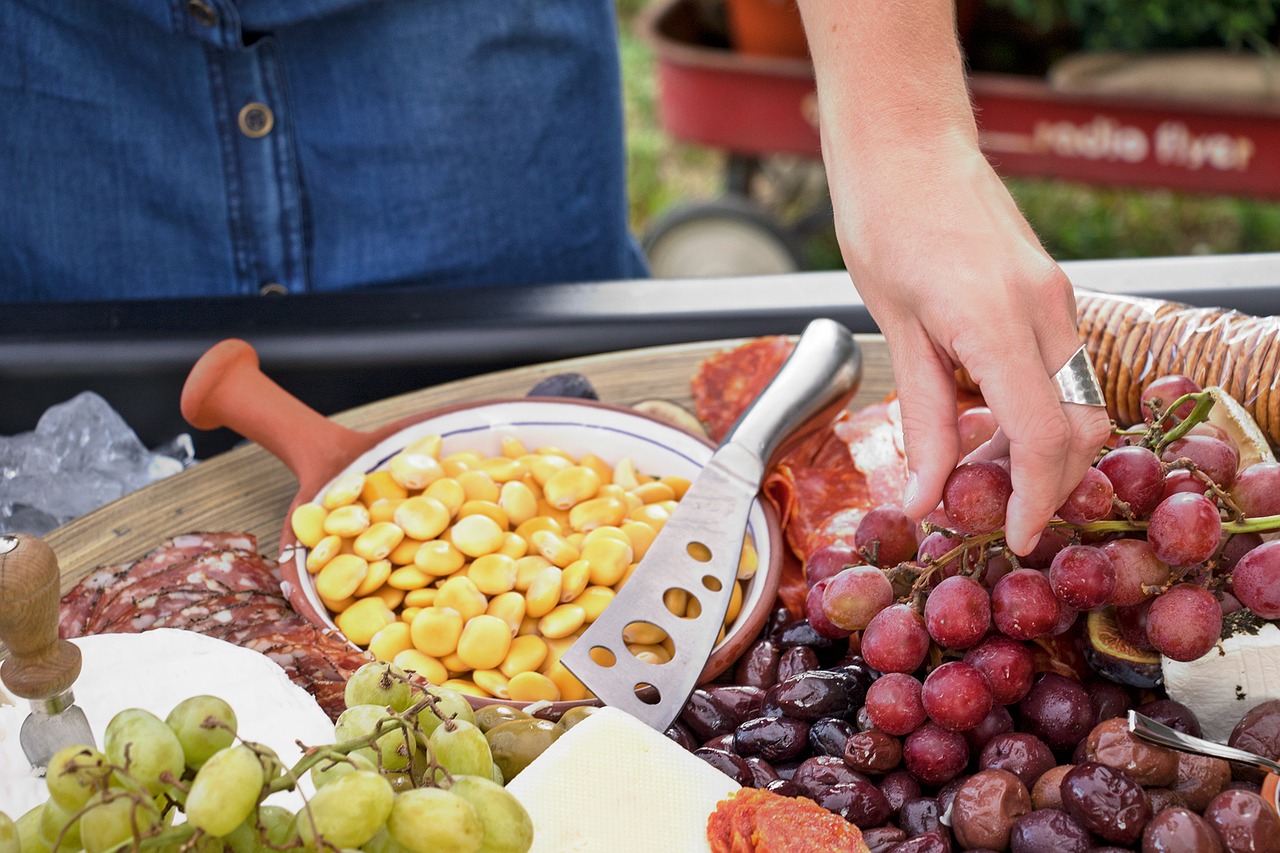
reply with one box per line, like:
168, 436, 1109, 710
0, 254, 1280, 457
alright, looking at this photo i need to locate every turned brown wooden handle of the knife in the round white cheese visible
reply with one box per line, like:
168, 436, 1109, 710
0, 533, 81, 701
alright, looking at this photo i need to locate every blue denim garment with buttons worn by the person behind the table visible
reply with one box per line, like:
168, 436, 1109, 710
0, 0, 644, 301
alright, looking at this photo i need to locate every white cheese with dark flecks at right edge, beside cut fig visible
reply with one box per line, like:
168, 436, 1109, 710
1160, 622, 1280, 743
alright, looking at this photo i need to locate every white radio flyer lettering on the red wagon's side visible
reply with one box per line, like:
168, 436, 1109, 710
1013, 115, 1257, 172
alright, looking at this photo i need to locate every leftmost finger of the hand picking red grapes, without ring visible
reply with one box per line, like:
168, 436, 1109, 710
893, 329, 960, 520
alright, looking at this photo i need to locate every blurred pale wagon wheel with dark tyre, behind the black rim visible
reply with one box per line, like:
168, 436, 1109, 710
643, 195, 805, 278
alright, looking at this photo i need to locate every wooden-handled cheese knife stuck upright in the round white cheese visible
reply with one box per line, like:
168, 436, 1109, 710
0, 533, 93, 771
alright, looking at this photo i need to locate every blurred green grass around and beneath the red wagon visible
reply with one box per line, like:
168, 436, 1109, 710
618, 0, 1280, 269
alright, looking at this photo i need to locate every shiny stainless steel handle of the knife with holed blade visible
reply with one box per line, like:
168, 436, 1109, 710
724, 318, 863, 464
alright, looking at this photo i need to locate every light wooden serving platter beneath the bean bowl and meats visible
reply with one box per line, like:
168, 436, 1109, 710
45, 334, 893, 592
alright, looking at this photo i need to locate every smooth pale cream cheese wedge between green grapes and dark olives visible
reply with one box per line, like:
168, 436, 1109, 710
507, 708, 739, 853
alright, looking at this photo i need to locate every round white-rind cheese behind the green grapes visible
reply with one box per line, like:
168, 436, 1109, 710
0, 629, 334, 818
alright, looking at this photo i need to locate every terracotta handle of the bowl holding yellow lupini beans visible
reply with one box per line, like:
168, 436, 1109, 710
182, 338, 370, 497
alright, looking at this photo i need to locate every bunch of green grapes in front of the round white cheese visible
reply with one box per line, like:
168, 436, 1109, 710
0, 662, 534, 853
